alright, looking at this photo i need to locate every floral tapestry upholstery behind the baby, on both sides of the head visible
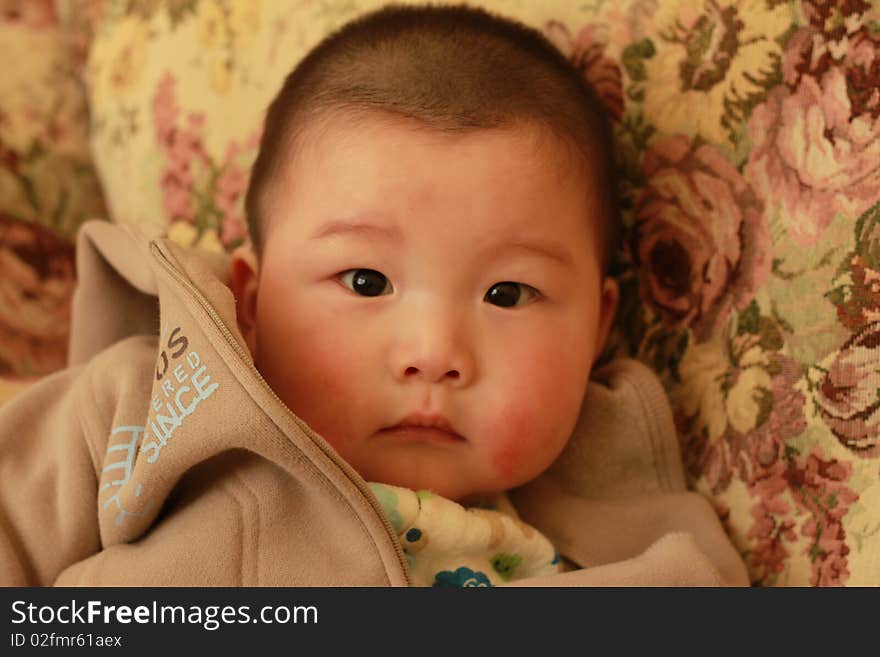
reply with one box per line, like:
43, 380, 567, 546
0, 0, 880, 586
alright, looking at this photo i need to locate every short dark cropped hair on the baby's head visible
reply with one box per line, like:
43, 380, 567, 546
245, 5, 620, 270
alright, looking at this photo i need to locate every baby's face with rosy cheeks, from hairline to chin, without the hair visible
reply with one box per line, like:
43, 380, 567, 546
232, 117, 617, 500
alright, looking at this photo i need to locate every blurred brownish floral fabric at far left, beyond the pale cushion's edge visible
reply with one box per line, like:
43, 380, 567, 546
0, 0, 105, 400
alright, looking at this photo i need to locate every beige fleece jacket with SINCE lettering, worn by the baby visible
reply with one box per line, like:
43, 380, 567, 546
0, 222, 748, 586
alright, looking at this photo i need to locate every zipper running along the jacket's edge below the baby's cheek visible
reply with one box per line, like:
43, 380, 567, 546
150, 242, 413, 586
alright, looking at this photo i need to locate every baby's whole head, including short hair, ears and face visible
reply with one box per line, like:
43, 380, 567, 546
231, 7, 618, 500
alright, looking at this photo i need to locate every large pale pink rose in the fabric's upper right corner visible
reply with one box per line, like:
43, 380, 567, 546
746, 2, 880, 246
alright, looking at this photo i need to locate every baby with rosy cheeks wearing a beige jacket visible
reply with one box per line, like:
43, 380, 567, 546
0, 0, 747, 586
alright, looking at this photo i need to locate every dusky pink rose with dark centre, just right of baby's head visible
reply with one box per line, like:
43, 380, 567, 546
631, 135, 770, 340
